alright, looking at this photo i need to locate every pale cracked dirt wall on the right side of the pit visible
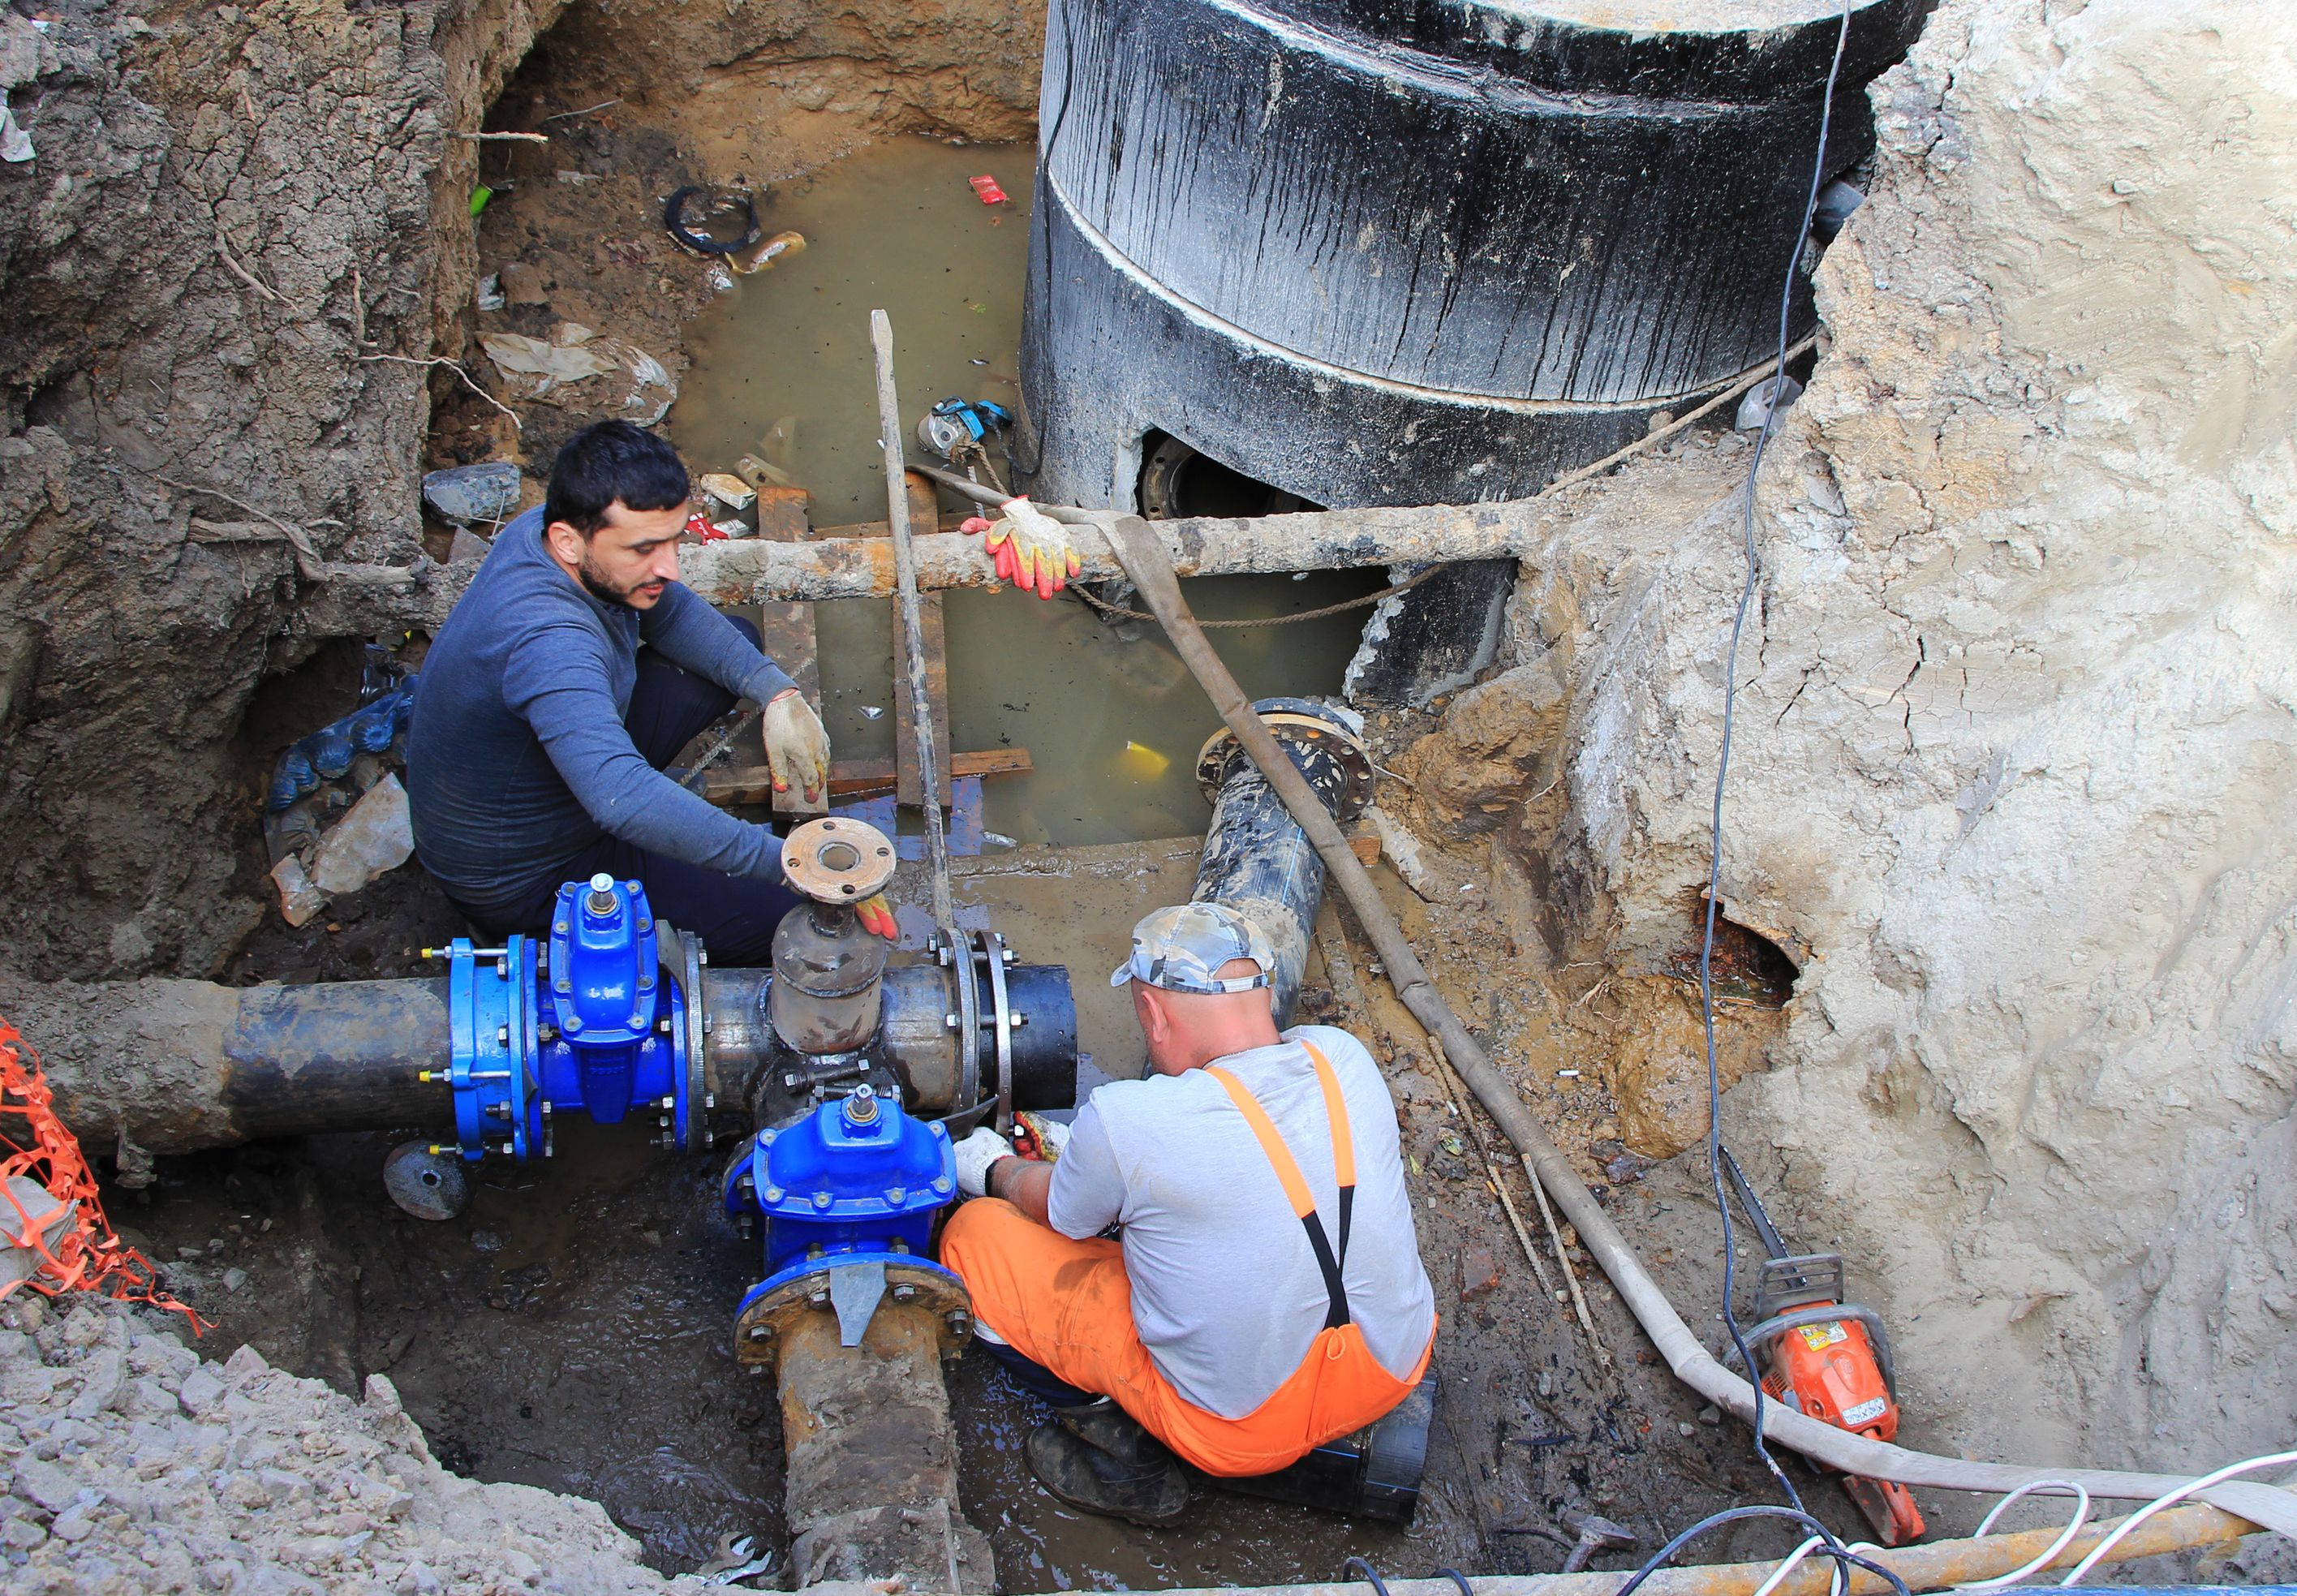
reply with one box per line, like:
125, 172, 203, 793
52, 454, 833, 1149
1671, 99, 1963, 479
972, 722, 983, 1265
1396, 0, 2297, 1465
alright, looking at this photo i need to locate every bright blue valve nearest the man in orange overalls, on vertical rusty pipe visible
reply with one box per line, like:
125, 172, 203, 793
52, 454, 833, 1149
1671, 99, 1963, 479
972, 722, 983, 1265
724, 1095, 958, 1309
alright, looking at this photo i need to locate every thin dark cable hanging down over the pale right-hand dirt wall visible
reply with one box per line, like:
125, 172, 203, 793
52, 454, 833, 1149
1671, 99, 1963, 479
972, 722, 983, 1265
1699, 0, 1856, 1525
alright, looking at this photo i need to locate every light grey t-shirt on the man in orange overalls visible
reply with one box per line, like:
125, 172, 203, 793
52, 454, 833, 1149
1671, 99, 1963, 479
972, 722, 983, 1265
1050, 1026, 1435, 1419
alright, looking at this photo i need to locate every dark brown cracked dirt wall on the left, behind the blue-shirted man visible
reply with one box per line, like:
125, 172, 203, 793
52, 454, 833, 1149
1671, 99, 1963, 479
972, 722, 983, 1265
0, 0, 556, 976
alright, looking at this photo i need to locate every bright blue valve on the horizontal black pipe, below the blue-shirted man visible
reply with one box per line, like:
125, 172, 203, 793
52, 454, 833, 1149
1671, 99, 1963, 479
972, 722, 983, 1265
448, 882, 703, 1159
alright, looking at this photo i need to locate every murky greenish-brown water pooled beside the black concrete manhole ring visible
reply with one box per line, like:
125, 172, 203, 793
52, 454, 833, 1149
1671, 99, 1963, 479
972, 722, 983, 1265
671, 138, 1380, 843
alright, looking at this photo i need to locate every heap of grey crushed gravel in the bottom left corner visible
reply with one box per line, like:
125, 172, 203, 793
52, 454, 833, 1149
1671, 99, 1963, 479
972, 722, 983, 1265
0, 1297, 679, 1596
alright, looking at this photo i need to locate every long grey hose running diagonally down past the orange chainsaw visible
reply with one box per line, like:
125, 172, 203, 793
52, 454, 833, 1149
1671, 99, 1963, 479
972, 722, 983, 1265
1094, 512, 2297, 1534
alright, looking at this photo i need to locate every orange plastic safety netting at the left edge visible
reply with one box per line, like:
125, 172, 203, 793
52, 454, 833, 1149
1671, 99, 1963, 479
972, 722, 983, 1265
0, 1020, 207, 1334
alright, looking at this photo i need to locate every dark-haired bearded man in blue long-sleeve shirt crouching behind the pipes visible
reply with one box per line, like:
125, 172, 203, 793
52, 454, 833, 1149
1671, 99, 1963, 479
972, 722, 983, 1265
406, 420, 893, 965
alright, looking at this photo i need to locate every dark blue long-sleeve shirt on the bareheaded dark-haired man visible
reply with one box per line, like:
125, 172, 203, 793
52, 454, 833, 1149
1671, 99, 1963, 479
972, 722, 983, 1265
406, 507, 790, 914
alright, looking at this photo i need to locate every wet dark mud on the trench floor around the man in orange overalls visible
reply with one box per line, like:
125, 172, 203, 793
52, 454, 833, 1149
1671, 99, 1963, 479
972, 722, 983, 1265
98, 838, 1856, 1591
